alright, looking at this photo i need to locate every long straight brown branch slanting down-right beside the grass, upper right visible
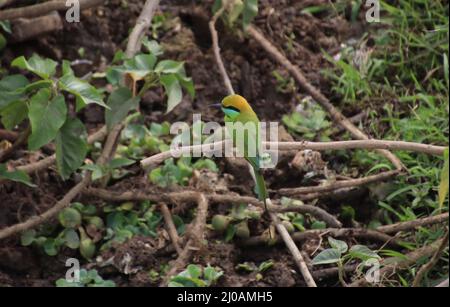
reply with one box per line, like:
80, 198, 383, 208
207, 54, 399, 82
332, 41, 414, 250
248, 25, 403, 169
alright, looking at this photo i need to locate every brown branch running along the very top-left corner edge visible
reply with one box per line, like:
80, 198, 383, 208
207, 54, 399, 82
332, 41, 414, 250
0, 0, 105, 20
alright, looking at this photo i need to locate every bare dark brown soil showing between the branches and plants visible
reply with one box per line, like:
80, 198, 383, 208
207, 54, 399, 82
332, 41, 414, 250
0, 0, 367, 286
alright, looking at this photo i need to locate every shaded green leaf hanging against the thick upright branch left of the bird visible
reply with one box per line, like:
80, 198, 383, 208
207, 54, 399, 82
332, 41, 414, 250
105, 87, 140, 129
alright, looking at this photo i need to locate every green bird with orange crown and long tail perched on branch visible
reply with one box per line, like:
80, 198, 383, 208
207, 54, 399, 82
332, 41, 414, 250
213, 94, 268, 212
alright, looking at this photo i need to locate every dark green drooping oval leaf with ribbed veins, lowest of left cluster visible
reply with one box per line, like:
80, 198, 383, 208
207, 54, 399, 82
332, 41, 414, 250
56, 118, 88, 179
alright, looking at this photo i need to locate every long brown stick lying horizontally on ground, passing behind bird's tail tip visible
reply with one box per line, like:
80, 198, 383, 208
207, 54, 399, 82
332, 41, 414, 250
83, 188, 342, 228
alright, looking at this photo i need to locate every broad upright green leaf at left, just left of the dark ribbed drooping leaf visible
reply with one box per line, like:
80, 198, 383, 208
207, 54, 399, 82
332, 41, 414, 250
28, 89, 67, 150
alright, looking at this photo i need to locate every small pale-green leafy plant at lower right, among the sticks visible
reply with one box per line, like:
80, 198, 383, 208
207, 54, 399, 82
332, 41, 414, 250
312, 237, 381, 285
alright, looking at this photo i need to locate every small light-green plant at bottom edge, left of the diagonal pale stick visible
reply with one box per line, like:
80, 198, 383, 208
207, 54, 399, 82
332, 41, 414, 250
169, 264, 223, 287
